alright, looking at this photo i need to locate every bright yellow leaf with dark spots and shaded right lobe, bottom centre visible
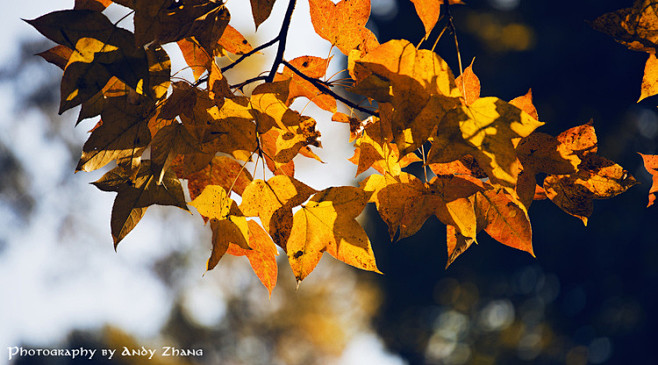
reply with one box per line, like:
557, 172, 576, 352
286, 186, 379, 281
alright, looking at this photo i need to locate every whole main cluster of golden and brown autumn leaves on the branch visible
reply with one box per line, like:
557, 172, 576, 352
28, 0, 636, 292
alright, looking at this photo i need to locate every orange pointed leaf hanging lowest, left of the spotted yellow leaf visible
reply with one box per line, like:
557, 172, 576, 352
226, 220, 279, 296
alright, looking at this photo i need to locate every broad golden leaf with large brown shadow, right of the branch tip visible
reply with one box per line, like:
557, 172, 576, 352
349, 40, 461, 155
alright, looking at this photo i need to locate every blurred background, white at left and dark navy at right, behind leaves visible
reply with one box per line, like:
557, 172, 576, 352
0, 0, 658, 365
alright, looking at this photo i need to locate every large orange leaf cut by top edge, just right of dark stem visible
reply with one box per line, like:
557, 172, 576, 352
309, 0, 379, 55
